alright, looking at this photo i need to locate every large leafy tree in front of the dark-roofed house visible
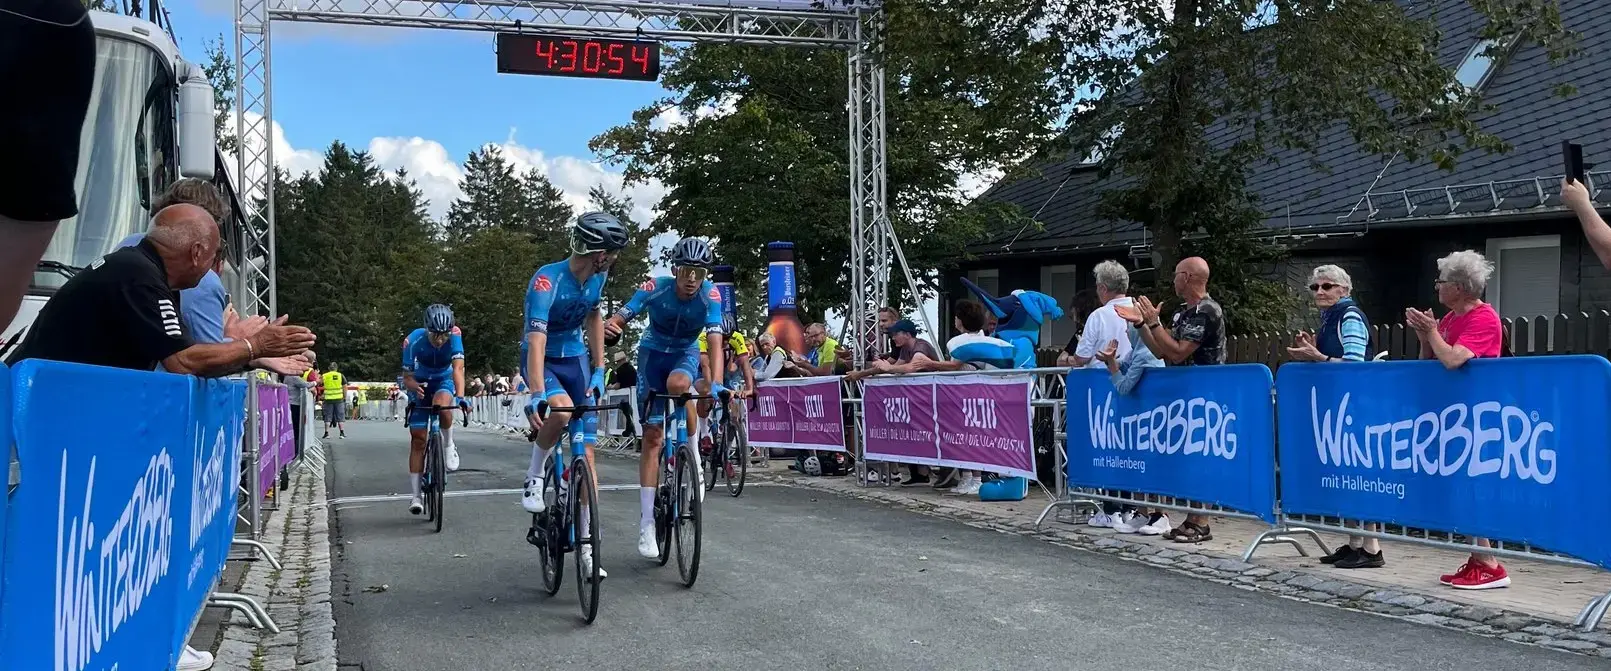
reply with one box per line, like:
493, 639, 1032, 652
1044, 0, 1576, 331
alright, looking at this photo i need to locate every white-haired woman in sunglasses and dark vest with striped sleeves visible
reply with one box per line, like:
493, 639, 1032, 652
1287, 266, 1387, 568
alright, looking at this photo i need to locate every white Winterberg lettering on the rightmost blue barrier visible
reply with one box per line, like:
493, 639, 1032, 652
1310, 388, 1556, 484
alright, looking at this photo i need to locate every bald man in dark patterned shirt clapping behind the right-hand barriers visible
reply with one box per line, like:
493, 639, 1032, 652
1120, 256, 1224, 542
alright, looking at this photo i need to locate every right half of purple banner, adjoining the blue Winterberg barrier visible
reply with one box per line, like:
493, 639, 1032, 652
934, 375, 1034, 480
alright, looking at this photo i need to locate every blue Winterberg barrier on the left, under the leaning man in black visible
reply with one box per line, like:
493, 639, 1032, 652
0, 360, 245, 671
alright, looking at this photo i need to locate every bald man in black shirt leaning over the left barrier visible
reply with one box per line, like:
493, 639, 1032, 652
8, 204, 314, 377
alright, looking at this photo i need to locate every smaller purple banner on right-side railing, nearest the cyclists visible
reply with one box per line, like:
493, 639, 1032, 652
746, 378, 846, 452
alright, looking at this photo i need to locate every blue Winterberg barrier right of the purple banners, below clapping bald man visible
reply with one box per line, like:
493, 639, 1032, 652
1063, 364, 1276, 523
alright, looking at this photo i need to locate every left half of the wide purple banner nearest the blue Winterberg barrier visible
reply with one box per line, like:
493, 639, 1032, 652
862, 378, 941, 465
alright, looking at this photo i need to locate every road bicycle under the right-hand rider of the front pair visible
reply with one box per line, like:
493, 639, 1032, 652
649, 391, 733, 587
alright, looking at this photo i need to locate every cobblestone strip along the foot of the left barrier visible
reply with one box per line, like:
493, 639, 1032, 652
213, 470, 337, 671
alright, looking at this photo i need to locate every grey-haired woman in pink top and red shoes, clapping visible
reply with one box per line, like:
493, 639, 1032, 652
1405, 249, 1510, 589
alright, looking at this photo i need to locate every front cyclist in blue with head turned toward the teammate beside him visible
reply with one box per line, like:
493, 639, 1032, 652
520, 212, 627, 578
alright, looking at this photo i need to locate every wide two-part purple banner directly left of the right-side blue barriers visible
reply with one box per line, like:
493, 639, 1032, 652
862, 375, 1034, 480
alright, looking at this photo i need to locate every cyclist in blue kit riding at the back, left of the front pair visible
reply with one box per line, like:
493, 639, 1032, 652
403, 303, 464, 515
